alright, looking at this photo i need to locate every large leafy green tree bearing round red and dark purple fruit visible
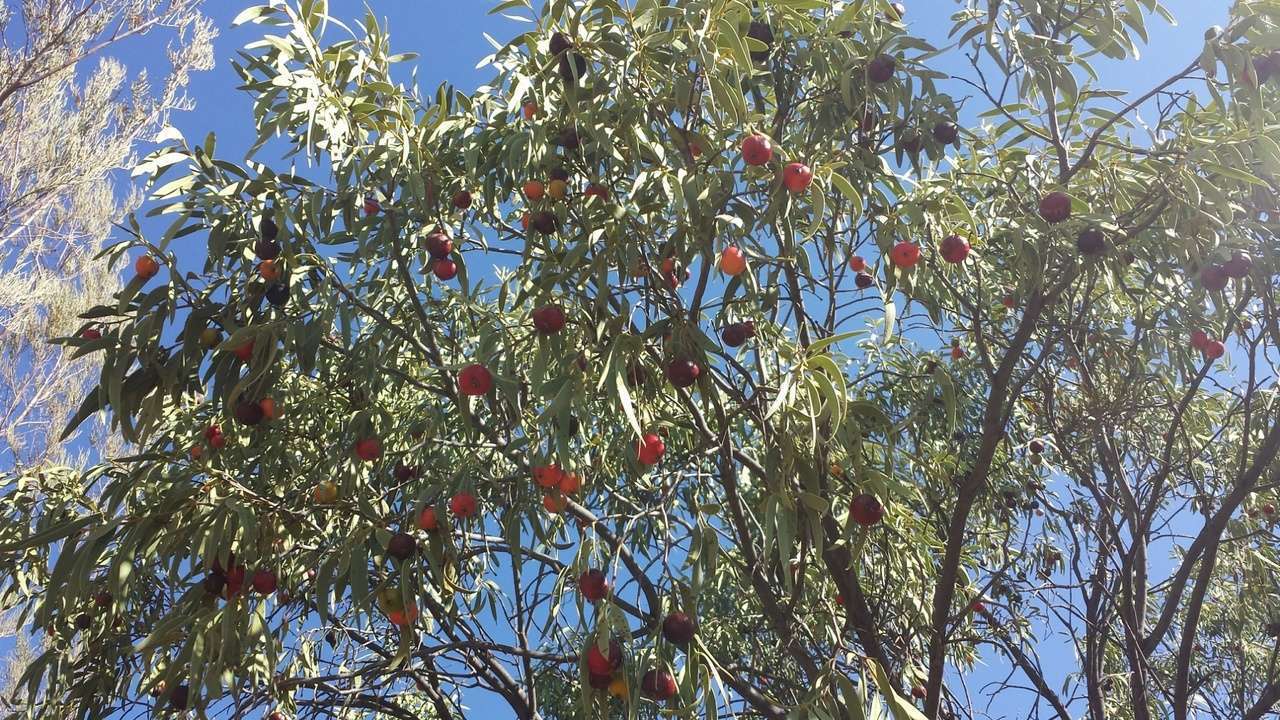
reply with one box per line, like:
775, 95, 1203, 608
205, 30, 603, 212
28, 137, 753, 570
0, 0, 1280, 720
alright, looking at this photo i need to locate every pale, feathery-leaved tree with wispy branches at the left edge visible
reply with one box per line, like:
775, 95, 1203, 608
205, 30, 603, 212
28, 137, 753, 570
0, 0, 215, 469
